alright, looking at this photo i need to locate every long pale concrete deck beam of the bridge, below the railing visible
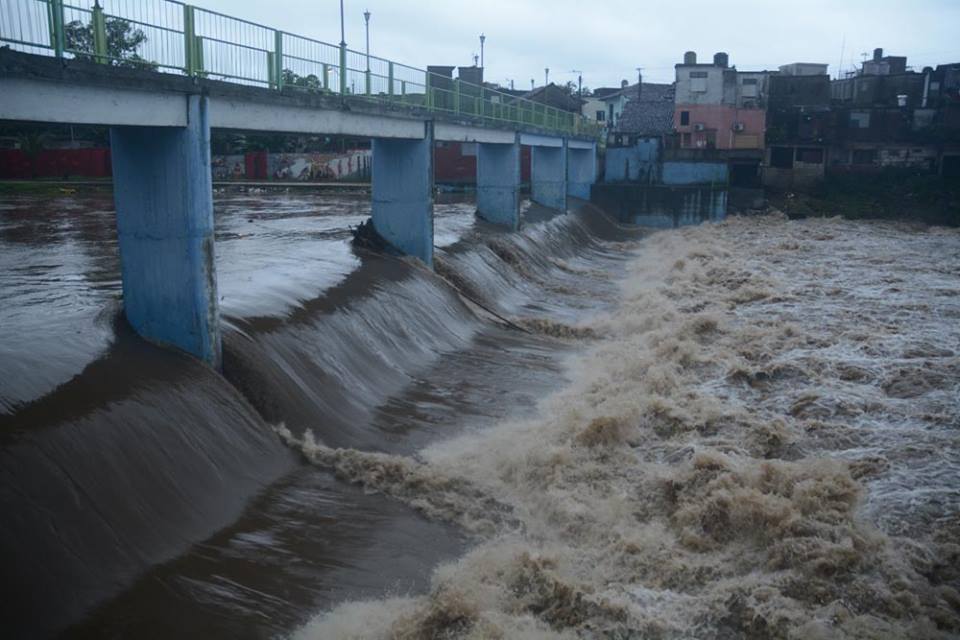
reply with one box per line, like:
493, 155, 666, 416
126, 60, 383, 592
0, 50, 595, 148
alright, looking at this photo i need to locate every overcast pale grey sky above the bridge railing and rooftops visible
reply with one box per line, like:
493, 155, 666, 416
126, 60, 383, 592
199, 0, 960, 88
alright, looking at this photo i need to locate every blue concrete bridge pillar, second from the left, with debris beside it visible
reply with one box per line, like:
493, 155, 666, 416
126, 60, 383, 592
373, 122, 433, 267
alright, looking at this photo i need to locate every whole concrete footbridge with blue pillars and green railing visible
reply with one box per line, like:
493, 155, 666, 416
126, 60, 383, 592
0, 0, 596, 367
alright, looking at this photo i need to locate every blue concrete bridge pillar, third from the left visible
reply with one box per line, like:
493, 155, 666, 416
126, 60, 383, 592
477, 134, 520, 230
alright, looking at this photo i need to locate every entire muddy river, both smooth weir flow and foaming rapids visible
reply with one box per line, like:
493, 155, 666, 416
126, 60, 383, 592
0, 195, 960, 639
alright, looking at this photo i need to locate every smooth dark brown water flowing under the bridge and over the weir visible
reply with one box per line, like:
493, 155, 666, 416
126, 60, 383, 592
0, 194, 636, 638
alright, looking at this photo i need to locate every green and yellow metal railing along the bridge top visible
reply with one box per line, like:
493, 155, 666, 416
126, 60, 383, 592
0, 0, 600, 136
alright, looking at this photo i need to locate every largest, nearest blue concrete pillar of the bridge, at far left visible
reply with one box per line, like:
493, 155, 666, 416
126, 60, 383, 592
110, 96, 220, 368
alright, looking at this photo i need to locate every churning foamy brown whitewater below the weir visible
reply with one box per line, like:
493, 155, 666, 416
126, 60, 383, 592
281, 215, 960, 639
